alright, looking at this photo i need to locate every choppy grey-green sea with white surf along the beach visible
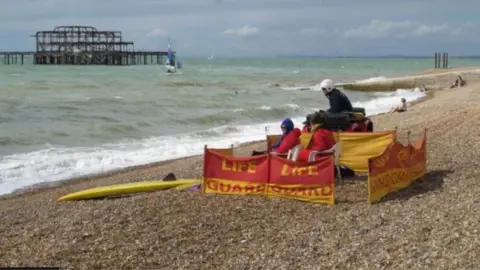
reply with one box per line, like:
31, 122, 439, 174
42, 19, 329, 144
0, 57, 476, 194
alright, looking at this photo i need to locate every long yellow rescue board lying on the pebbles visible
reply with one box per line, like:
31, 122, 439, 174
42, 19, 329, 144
57, 179, 202, 202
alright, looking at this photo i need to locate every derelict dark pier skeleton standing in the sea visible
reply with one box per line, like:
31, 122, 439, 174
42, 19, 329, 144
0, 26, 172, 66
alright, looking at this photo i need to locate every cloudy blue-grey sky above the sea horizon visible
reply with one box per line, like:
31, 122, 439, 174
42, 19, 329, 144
0, 0, 480, 57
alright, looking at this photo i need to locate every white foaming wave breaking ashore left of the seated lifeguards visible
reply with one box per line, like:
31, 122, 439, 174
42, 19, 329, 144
0, 120, 288, 194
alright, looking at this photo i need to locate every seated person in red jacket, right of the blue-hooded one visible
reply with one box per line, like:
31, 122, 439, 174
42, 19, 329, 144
297, 112, 336, 161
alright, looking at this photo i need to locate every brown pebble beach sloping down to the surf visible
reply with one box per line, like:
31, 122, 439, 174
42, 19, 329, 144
0, 70, 480, 269
